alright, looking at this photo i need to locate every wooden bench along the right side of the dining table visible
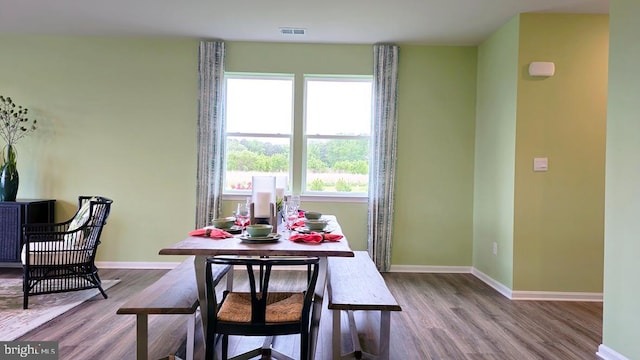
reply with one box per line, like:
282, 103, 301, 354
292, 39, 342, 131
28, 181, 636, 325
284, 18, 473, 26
327, 251, 402, 360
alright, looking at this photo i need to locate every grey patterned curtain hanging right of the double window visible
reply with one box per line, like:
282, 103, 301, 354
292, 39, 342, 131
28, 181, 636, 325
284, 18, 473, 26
368, 45, 399, 271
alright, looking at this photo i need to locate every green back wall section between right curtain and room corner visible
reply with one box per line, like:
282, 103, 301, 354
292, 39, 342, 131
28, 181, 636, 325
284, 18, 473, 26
391, 46, 477, 266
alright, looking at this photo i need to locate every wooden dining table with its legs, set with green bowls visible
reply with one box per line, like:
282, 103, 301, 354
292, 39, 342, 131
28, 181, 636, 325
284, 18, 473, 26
159, 215, 354, 359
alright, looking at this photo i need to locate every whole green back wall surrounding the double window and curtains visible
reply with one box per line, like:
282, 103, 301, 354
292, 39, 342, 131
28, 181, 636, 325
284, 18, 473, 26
0, 35, 475, 265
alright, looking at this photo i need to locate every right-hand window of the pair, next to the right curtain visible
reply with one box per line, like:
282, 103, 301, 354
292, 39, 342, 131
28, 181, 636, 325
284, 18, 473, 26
303, 76, 371, 194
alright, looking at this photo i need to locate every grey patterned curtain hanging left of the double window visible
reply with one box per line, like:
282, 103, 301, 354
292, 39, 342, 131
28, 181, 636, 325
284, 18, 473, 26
196, 41, 225, 228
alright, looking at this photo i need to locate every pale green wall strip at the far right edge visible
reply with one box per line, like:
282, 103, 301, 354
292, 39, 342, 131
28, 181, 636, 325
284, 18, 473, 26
603, 0, 640, 359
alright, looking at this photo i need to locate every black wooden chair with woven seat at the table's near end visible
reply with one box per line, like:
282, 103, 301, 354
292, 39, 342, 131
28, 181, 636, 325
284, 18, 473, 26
205, 256, 319, 360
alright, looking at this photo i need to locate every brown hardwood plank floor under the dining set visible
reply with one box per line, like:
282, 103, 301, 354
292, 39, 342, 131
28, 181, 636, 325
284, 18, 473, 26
5, 269, 602, 360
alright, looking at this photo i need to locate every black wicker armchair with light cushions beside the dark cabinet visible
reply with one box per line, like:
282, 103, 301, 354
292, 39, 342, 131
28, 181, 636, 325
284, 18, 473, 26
21, 196, 113, 309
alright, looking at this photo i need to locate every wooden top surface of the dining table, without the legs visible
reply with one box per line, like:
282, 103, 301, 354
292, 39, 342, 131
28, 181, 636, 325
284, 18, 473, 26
160, 217, 353, 257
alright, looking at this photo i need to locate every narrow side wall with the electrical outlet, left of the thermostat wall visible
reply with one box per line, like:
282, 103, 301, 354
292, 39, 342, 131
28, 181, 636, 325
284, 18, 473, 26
473, 17, 519, 288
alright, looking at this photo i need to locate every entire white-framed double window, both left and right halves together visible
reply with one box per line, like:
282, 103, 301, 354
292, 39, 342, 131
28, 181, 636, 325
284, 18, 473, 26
224, 73, 372, 197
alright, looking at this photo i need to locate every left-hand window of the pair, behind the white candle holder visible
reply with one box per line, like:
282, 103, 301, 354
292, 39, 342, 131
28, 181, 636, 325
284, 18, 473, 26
224, 74, 293, 193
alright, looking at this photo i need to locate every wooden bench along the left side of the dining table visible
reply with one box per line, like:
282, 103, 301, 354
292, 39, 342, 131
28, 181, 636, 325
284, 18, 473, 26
117, 256, 231, 360
